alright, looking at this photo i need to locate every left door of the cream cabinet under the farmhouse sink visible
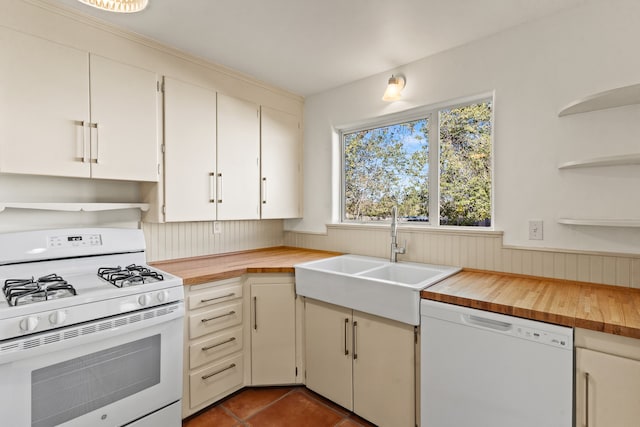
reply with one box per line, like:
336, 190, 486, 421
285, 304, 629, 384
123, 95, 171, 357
305, 299, 353, 410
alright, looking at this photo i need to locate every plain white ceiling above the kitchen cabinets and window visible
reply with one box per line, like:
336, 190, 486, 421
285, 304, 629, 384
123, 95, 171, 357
56, 0, 585, 96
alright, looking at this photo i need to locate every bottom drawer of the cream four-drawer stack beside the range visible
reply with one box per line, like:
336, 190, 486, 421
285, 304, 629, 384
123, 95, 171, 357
189, 353, 244, 408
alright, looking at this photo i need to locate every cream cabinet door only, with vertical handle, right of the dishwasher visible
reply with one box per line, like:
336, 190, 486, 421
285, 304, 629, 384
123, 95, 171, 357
576, 348, 640, 427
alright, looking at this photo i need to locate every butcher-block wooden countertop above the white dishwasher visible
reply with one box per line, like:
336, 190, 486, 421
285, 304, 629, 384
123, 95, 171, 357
421, 269, 640, 338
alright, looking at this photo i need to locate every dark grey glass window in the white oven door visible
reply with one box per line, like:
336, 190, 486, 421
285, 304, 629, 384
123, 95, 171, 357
31, 334, 161, 427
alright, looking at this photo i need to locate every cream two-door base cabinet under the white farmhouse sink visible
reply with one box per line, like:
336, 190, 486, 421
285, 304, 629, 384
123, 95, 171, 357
305, 299, 416, 427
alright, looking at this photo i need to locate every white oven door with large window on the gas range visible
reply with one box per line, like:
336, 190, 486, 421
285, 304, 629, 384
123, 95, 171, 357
0, 302, 184, 427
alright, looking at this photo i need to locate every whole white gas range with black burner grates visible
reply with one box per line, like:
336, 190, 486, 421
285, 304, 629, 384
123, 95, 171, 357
0, 228, 184, 427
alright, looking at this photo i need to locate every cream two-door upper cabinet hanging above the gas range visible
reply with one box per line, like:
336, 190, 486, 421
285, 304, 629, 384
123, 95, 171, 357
0, 28, 159, 181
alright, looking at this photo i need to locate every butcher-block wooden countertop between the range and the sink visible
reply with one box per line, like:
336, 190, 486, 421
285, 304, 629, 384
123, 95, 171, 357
151, 246, 341, 285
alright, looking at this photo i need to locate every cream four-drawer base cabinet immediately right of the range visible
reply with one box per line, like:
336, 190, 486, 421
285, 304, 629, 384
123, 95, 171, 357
182, 279, 245, 417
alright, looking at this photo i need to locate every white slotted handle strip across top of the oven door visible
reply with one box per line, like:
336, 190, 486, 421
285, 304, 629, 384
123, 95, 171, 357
0, 301, 184, 365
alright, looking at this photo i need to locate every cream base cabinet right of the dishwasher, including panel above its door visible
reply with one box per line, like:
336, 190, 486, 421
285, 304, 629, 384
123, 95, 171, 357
575, 329, 640, 427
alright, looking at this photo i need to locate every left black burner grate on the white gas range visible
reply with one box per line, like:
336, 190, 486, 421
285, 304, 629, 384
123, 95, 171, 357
2, 274, 76, 306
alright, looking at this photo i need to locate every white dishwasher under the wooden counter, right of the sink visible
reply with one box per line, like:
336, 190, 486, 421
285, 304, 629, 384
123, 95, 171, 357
420, 300, 573, 427
